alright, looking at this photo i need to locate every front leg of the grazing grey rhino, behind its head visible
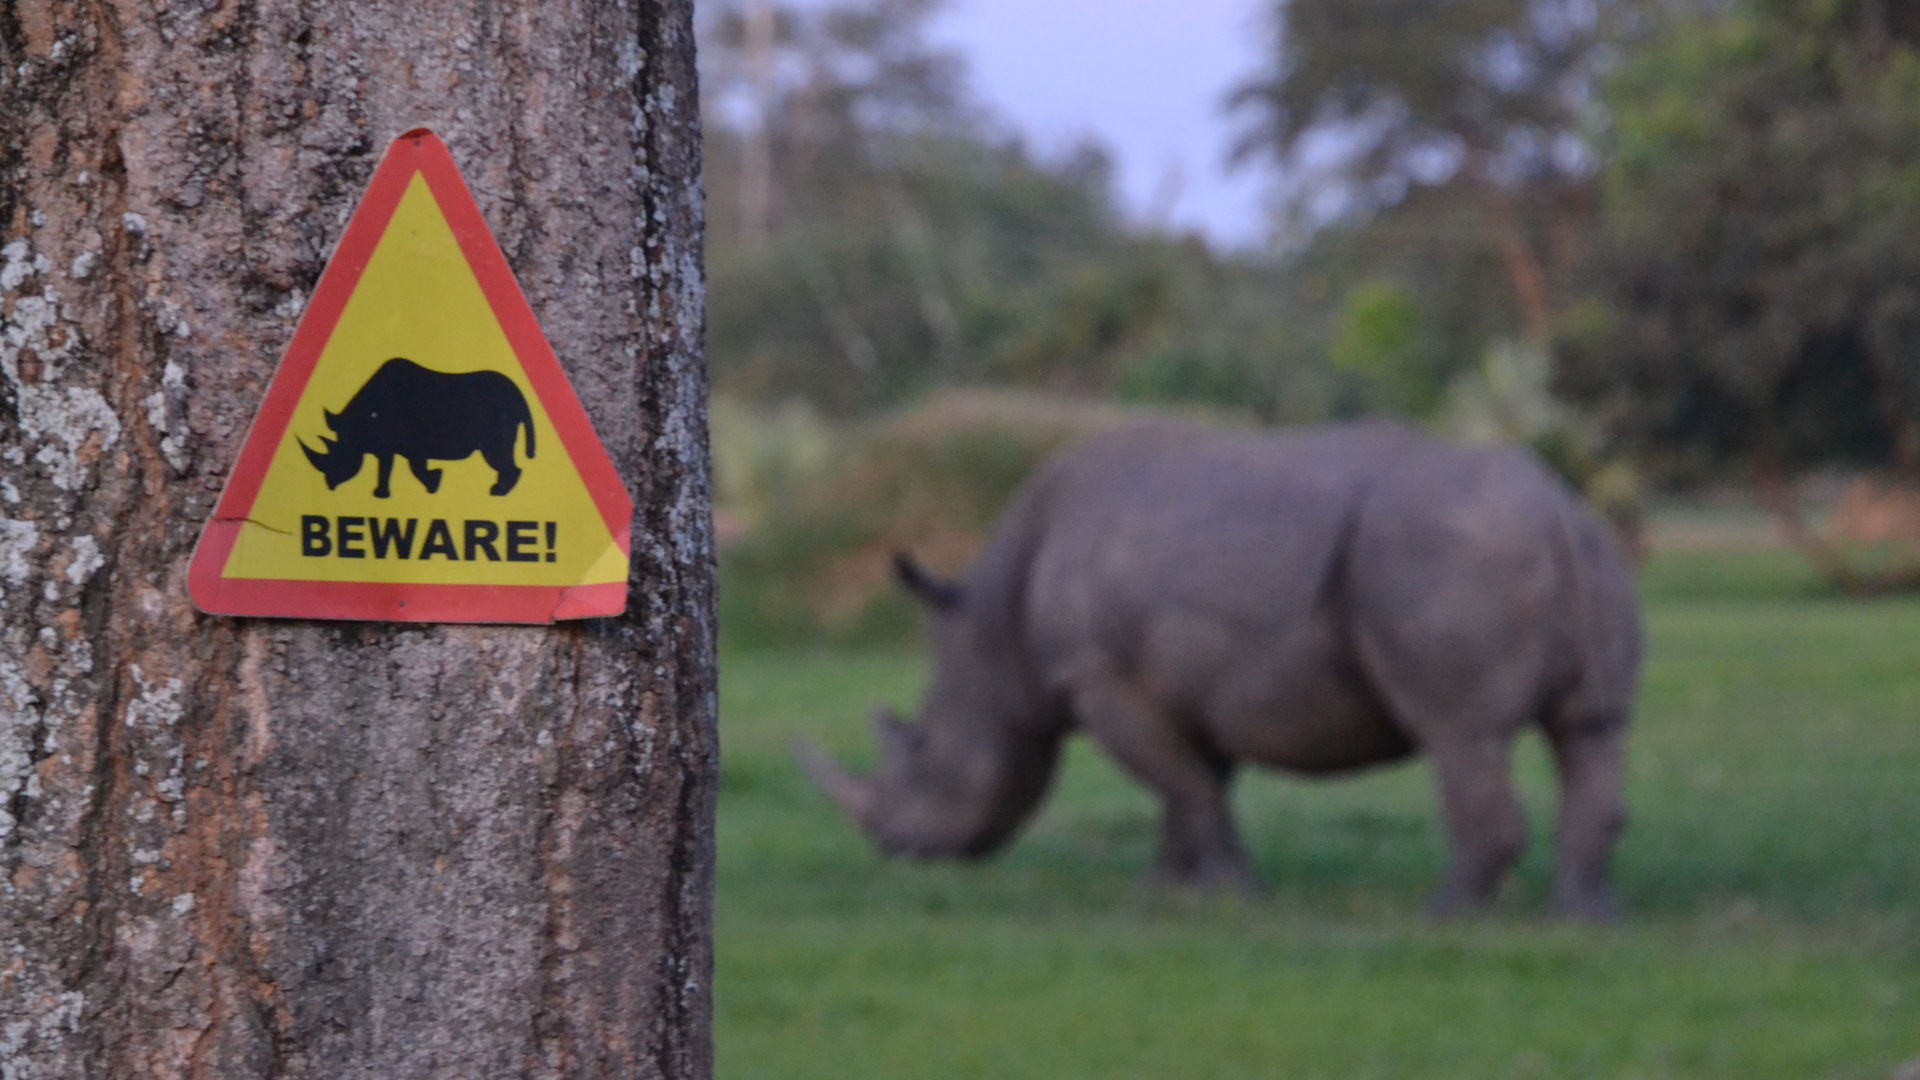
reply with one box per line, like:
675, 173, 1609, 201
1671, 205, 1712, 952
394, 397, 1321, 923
1073, 673, 1258, 892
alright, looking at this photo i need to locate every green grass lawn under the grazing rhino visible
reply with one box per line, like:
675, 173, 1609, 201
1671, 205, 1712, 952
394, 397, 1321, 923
716, 552, 1920, 1080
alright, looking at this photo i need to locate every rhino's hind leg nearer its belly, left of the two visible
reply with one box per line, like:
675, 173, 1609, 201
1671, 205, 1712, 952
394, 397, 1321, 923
1427, 736, 1526, 915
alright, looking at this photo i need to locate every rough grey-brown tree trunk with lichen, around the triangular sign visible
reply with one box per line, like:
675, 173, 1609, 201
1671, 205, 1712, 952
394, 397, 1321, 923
0, 0, 716, 1080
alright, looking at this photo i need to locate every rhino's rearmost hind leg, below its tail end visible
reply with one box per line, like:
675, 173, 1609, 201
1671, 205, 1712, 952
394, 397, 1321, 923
1548, 724, 1626, 922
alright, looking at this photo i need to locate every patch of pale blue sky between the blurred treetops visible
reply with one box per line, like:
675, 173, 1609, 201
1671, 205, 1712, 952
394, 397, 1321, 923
933, 0, 1269, 246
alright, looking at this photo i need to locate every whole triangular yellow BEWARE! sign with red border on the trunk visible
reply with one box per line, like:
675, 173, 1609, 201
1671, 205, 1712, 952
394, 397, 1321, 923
188, 131, 634, 623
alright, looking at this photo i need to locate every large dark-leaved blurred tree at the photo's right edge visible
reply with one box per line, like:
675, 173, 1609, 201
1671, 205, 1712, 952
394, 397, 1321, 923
1559, 0, 1920, 590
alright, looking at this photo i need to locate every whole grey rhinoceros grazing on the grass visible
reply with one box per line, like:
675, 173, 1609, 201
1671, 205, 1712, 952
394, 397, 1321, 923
795, 421, 1642, 919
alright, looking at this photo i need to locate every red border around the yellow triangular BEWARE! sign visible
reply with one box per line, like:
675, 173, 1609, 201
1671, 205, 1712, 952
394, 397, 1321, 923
186, 127, 634, 623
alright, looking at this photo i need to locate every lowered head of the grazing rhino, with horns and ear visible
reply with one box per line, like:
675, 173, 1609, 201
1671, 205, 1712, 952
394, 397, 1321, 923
795, 555, 1064, 859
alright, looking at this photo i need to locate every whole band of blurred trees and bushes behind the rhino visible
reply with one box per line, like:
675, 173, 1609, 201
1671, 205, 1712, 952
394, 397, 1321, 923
703, 0, 1920, 638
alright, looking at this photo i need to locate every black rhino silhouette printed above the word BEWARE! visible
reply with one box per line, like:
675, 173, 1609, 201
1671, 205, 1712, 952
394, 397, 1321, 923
300, 356, 534, 500
